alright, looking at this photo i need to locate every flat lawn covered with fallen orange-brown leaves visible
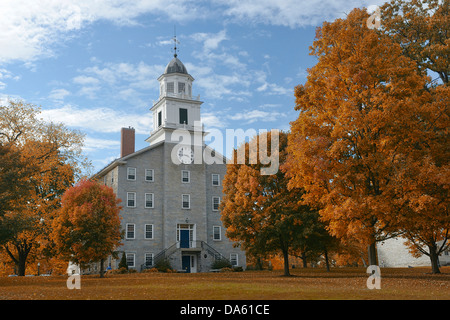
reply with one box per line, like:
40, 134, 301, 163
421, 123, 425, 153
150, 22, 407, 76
0, 267, 450, 300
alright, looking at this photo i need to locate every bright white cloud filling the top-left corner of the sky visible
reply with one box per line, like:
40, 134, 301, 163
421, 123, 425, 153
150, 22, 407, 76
0, 0, 209, 62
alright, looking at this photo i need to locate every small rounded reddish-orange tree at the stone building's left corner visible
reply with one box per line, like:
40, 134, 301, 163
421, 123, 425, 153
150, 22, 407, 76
52, 179, 122, 277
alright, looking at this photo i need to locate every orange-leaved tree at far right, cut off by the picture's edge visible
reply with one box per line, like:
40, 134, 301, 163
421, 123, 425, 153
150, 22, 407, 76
381, 0, 450, 273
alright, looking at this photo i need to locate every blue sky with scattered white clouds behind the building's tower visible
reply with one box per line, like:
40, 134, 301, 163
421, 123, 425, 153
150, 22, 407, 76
0, 0, 384, 172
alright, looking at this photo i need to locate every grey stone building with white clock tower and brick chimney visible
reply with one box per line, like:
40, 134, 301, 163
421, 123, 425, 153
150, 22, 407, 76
95, 54, 246, 272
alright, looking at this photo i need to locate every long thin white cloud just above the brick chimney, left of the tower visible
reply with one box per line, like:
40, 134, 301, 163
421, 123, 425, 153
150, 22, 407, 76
41, 105, 153, 134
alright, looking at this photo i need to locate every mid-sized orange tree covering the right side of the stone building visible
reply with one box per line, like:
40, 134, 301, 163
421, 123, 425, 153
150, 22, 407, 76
221, 132, 324, 275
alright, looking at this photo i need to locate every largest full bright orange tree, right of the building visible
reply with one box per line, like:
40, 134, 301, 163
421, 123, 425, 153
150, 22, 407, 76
287, 9, 440, 265
